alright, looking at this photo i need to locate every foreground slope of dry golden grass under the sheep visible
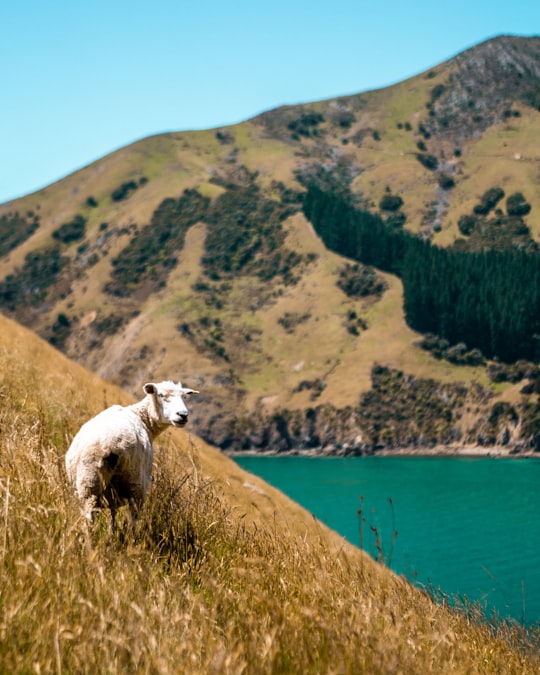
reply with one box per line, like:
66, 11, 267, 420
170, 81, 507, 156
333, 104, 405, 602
0, 318, 540, 673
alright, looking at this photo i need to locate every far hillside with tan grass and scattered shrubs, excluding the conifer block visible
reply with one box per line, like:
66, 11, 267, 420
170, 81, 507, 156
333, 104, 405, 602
0, 37, 540, 452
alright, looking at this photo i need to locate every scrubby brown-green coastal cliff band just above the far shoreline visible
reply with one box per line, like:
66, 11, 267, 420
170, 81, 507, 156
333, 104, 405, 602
197, 365, 540, 455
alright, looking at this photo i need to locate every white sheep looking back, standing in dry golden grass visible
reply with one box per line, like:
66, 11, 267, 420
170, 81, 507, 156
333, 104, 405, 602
66, 382, 199, 529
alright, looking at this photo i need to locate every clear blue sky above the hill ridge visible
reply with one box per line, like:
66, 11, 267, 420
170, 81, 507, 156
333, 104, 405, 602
0, 0, 540, 203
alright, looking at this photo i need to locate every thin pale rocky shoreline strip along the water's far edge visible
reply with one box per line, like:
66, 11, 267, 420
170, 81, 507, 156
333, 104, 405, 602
222, 445, 540, 459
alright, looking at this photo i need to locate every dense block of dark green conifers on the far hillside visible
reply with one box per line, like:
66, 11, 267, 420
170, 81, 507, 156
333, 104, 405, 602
304, 188, 540, 362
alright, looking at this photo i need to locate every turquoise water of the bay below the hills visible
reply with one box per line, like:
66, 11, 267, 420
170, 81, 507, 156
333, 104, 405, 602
235, 456, 540, 625
